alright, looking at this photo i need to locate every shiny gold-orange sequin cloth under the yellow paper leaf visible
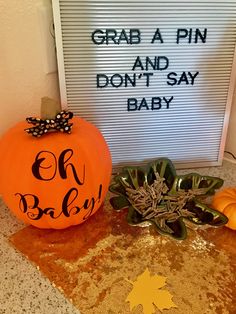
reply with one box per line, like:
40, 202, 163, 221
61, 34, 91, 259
10, 195, 236, 314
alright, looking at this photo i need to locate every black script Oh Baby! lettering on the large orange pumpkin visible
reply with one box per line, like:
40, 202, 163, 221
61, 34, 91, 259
15, 148, 102, 220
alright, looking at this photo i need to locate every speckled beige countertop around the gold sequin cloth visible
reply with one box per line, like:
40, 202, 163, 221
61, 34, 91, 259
0, 161, 236, 314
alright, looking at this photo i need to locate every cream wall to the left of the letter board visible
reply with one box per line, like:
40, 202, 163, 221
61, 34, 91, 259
0, 0, 59, 134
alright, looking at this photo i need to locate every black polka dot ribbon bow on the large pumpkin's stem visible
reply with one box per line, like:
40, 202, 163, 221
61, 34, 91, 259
25, 110, 73, 137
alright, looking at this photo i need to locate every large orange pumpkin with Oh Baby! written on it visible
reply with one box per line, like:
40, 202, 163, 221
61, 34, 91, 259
0, 117, 112, 229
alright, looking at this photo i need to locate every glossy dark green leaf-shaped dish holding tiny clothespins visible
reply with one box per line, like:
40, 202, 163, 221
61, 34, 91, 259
110, 158, 228, 240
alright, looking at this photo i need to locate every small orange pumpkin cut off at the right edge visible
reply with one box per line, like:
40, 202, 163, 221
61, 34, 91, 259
212, 188, 236, 230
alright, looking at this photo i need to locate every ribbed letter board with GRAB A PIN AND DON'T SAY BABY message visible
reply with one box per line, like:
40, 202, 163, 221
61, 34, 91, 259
53, 0, 236, 166
